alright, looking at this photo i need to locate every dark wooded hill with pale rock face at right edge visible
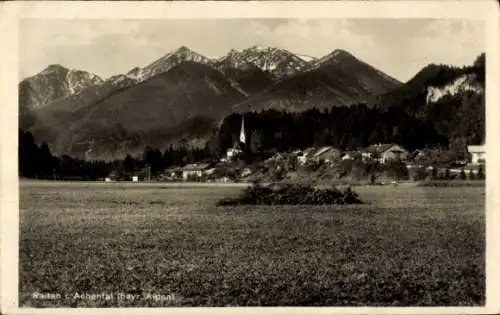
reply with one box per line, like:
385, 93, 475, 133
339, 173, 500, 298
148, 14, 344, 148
377, 54, 485, 146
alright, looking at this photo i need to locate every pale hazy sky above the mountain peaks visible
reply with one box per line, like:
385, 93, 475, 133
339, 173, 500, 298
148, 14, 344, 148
19, 19, 486, 82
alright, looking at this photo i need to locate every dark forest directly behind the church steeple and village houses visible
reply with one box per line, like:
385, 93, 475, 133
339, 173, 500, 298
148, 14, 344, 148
210, 104, 449, 157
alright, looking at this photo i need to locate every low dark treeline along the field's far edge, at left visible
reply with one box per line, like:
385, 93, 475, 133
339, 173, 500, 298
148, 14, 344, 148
18, 129, 210, 180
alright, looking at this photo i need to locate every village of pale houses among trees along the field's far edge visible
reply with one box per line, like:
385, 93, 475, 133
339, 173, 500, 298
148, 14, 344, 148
105, 143, 486, 184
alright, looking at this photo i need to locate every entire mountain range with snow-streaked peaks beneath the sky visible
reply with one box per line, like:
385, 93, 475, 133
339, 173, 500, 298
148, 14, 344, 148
19, 46, 482, 159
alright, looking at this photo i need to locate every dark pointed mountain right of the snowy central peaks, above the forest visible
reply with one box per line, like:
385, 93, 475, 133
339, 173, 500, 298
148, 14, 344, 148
234, 50, 401, 112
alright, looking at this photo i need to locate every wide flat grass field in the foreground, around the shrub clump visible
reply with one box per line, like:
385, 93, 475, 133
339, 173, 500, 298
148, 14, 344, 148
19, 182, 485, 307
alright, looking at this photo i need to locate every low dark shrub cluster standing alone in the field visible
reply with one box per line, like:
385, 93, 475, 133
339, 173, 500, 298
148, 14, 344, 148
218, 184, 362, 206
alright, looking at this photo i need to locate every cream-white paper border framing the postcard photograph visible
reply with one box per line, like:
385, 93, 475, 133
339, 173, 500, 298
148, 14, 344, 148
0, 1, 500, 314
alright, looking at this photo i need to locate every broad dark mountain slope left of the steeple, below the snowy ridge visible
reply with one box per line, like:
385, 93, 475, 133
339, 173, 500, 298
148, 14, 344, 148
40, 62, 245, 158
